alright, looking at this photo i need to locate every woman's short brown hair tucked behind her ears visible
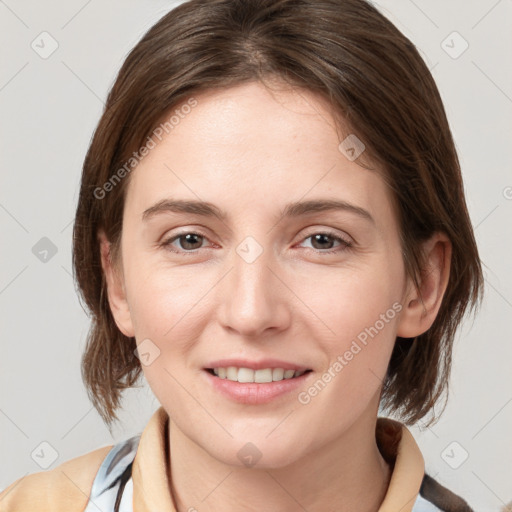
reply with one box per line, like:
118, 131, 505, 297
73, 0, 483, 425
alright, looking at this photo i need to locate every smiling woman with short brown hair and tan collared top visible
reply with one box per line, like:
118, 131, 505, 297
0, 0, 482, 512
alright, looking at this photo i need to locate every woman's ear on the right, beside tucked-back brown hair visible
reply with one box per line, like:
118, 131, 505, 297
397, 233, 452, 338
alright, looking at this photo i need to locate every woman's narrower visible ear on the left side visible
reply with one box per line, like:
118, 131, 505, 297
98, 230, 135, 337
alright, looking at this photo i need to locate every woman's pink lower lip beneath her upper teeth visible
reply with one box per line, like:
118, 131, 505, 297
203, 370, 312, 405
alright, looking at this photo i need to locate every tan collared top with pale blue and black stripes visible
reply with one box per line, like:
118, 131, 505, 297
0, 407, 472, 512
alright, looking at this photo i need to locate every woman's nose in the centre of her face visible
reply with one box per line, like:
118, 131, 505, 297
218, 246, 292, 338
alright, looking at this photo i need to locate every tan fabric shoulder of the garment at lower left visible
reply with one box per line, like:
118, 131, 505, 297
0, 445, 114, 512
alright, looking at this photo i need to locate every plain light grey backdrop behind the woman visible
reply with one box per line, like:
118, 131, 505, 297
0, 0, 512, 511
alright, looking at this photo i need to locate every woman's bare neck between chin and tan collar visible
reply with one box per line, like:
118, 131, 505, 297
169, 411, 391, 512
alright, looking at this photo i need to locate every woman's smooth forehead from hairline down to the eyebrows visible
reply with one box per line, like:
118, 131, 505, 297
127, 82, 396, 226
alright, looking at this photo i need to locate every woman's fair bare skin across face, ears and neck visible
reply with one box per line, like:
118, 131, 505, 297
99, 82, 451, 512
